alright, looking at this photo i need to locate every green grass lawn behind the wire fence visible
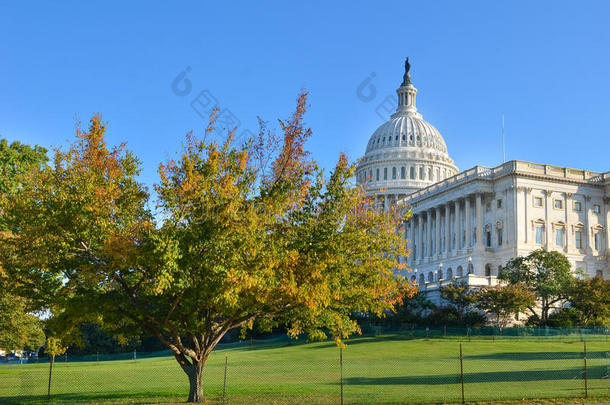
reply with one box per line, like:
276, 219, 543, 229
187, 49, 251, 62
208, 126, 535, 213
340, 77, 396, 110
0, 335, 610, 403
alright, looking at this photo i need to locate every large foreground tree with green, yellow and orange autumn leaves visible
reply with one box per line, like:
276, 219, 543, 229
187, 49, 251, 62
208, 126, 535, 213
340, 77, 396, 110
0, 94, 414, 402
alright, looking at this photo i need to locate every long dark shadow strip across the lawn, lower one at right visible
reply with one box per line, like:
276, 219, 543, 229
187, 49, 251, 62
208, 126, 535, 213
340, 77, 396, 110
340, 366, 607, 385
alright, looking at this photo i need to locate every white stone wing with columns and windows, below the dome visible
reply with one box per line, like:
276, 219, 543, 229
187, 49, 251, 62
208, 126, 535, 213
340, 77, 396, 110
397, 161, 610, 304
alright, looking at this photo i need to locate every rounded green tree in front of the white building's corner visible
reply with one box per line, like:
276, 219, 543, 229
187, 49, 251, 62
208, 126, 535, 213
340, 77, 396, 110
499, 249, 574, 325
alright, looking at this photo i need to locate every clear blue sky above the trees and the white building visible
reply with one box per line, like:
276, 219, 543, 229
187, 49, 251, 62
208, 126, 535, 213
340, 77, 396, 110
0, 0, 610, 189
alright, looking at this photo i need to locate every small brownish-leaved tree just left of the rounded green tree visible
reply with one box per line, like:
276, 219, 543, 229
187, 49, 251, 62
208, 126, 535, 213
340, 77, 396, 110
474, 284, 536, 331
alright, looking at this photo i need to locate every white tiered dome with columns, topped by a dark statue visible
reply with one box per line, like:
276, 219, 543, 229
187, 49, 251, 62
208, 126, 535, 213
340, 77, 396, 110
356, 58, 458, 201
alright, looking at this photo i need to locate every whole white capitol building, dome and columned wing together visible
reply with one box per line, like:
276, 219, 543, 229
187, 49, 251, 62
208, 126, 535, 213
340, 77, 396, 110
356, 59, 610, 300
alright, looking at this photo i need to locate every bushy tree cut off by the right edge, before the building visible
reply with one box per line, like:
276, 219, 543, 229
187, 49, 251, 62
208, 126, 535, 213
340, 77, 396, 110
568, 277, 610, 326
